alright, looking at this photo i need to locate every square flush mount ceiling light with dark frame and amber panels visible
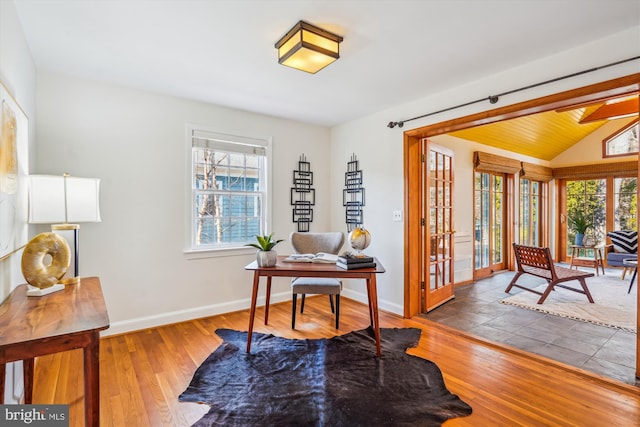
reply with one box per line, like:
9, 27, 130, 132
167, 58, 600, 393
275, 21, 342, 74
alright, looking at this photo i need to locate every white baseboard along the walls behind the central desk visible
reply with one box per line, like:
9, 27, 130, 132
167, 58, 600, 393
100, 289, 404, 337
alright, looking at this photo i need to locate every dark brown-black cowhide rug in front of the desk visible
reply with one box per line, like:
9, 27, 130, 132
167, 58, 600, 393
179, 328, 471, 426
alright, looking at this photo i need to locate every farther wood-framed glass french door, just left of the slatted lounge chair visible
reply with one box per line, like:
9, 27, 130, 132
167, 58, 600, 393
473, 172, 507, 280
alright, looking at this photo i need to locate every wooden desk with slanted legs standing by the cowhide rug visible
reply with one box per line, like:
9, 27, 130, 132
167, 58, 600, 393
245, 255, 385, 356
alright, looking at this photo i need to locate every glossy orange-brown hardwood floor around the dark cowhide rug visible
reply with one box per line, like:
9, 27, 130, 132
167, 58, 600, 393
34, 297, 640, 427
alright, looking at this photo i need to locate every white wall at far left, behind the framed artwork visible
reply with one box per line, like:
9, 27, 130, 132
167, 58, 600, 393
0, 1, 36, 403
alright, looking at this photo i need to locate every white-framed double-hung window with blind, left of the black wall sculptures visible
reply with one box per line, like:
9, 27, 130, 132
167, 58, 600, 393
188, 127, 270, 250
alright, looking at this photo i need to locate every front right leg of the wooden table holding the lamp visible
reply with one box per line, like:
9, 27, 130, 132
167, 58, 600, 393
83, 332, 100, 427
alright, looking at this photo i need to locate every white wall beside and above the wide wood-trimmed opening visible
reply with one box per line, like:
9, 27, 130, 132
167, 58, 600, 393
331, 26, 640, 314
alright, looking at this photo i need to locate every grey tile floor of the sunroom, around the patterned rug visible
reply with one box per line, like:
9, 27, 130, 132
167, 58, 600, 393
424, 270, 640, 387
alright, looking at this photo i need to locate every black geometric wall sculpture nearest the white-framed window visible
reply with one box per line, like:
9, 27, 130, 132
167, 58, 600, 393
291, 154, 316, 231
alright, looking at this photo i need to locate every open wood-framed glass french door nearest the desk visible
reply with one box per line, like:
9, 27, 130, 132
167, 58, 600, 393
422, 139, 455, 312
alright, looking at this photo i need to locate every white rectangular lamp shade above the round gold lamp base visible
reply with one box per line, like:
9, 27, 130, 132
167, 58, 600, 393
29, 175, 101, 224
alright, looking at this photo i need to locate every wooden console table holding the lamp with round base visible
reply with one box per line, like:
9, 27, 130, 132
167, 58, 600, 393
0, 277, 109, 427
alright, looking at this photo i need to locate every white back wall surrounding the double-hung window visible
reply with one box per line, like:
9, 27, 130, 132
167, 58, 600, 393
36, 73, 335, 334
